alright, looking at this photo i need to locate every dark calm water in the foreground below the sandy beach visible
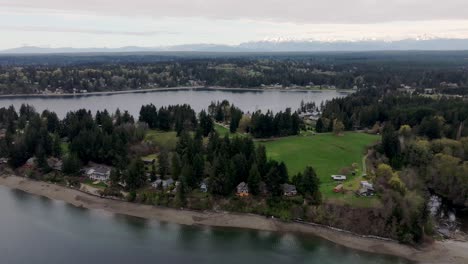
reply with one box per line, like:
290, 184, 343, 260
0, 186, 408, 264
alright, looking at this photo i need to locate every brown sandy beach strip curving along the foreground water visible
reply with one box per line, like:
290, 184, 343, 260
0, 175, 468, 263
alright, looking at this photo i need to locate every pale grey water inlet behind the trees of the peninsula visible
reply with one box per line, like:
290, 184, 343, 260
0, 89, 346, 117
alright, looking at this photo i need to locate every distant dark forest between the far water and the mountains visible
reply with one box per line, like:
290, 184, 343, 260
0, 52, 468, 94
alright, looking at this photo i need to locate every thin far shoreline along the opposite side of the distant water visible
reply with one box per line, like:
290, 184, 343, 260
0, 86, 353, 99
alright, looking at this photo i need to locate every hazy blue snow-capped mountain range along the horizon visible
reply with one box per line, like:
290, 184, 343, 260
0, 38, 468, 54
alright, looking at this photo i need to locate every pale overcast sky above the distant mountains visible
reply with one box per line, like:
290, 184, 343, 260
0, 0, 468, 50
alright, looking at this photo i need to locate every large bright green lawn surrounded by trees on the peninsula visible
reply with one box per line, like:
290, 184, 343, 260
261, 133, 380, 206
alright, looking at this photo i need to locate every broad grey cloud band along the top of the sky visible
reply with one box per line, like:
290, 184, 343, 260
0, 0, 468, 24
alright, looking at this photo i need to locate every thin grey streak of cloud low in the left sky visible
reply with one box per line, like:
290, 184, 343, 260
0, 25, 179, 36
